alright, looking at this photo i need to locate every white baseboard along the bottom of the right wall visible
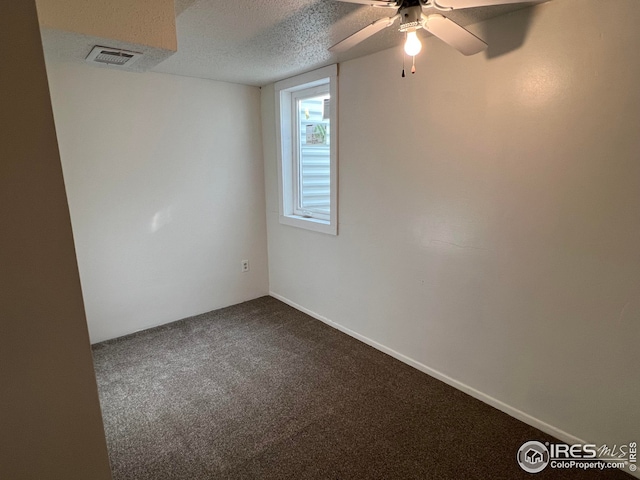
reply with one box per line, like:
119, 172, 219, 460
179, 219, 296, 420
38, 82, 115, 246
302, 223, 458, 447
269, 292, 640, 478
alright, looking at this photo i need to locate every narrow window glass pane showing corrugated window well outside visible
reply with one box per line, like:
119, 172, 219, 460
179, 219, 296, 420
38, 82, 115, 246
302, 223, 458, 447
297, 93, 331, 219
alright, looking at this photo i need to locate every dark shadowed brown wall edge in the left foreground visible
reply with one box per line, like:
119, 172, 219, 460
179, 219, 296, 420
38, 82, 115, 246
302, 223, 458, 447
0, 0, 111, 480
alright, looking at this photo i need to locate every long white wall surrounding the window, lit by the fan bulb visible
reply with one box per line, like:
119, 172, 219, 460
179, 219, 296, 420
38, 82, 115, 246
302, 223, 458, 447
262, 0, 640, 458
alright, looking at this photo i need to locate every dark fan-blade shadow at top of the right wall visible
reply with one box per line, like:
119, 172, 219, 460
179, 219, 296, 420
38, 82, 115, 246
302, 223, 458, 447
478, 6, 536, 59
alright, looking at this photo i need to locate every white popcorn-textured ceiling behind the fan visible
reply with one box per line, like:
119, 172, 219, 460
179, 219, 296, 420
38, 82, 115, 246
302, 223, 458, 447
153, 0, 539, 85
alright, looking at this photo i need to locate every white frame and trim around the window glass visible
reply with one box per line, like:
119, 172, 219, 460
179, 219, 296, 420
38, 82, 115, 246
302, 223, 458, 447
275, 65, 338, 235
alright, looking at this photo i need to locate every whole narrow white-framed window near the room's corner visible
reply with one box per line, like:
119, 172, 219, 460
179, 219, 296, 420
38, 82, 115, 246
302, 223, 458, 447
275, 65, 338, 235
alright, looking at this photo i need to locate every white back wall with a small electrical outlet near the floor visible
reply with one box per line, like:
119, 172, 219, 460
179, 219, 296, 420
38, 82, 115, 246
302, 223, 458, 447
47, 61, 268, 342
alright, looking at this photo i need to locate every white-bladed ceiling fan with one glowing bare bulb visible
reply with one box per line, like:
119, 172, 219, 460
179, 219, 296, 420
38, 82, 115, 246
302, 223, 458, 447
329, 0, 531, 61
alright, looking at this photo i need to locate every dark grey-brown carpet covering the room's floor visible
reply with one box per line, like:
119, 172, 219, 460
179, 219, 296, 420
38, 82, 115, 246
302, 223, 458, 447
94, 297, 631, 480
